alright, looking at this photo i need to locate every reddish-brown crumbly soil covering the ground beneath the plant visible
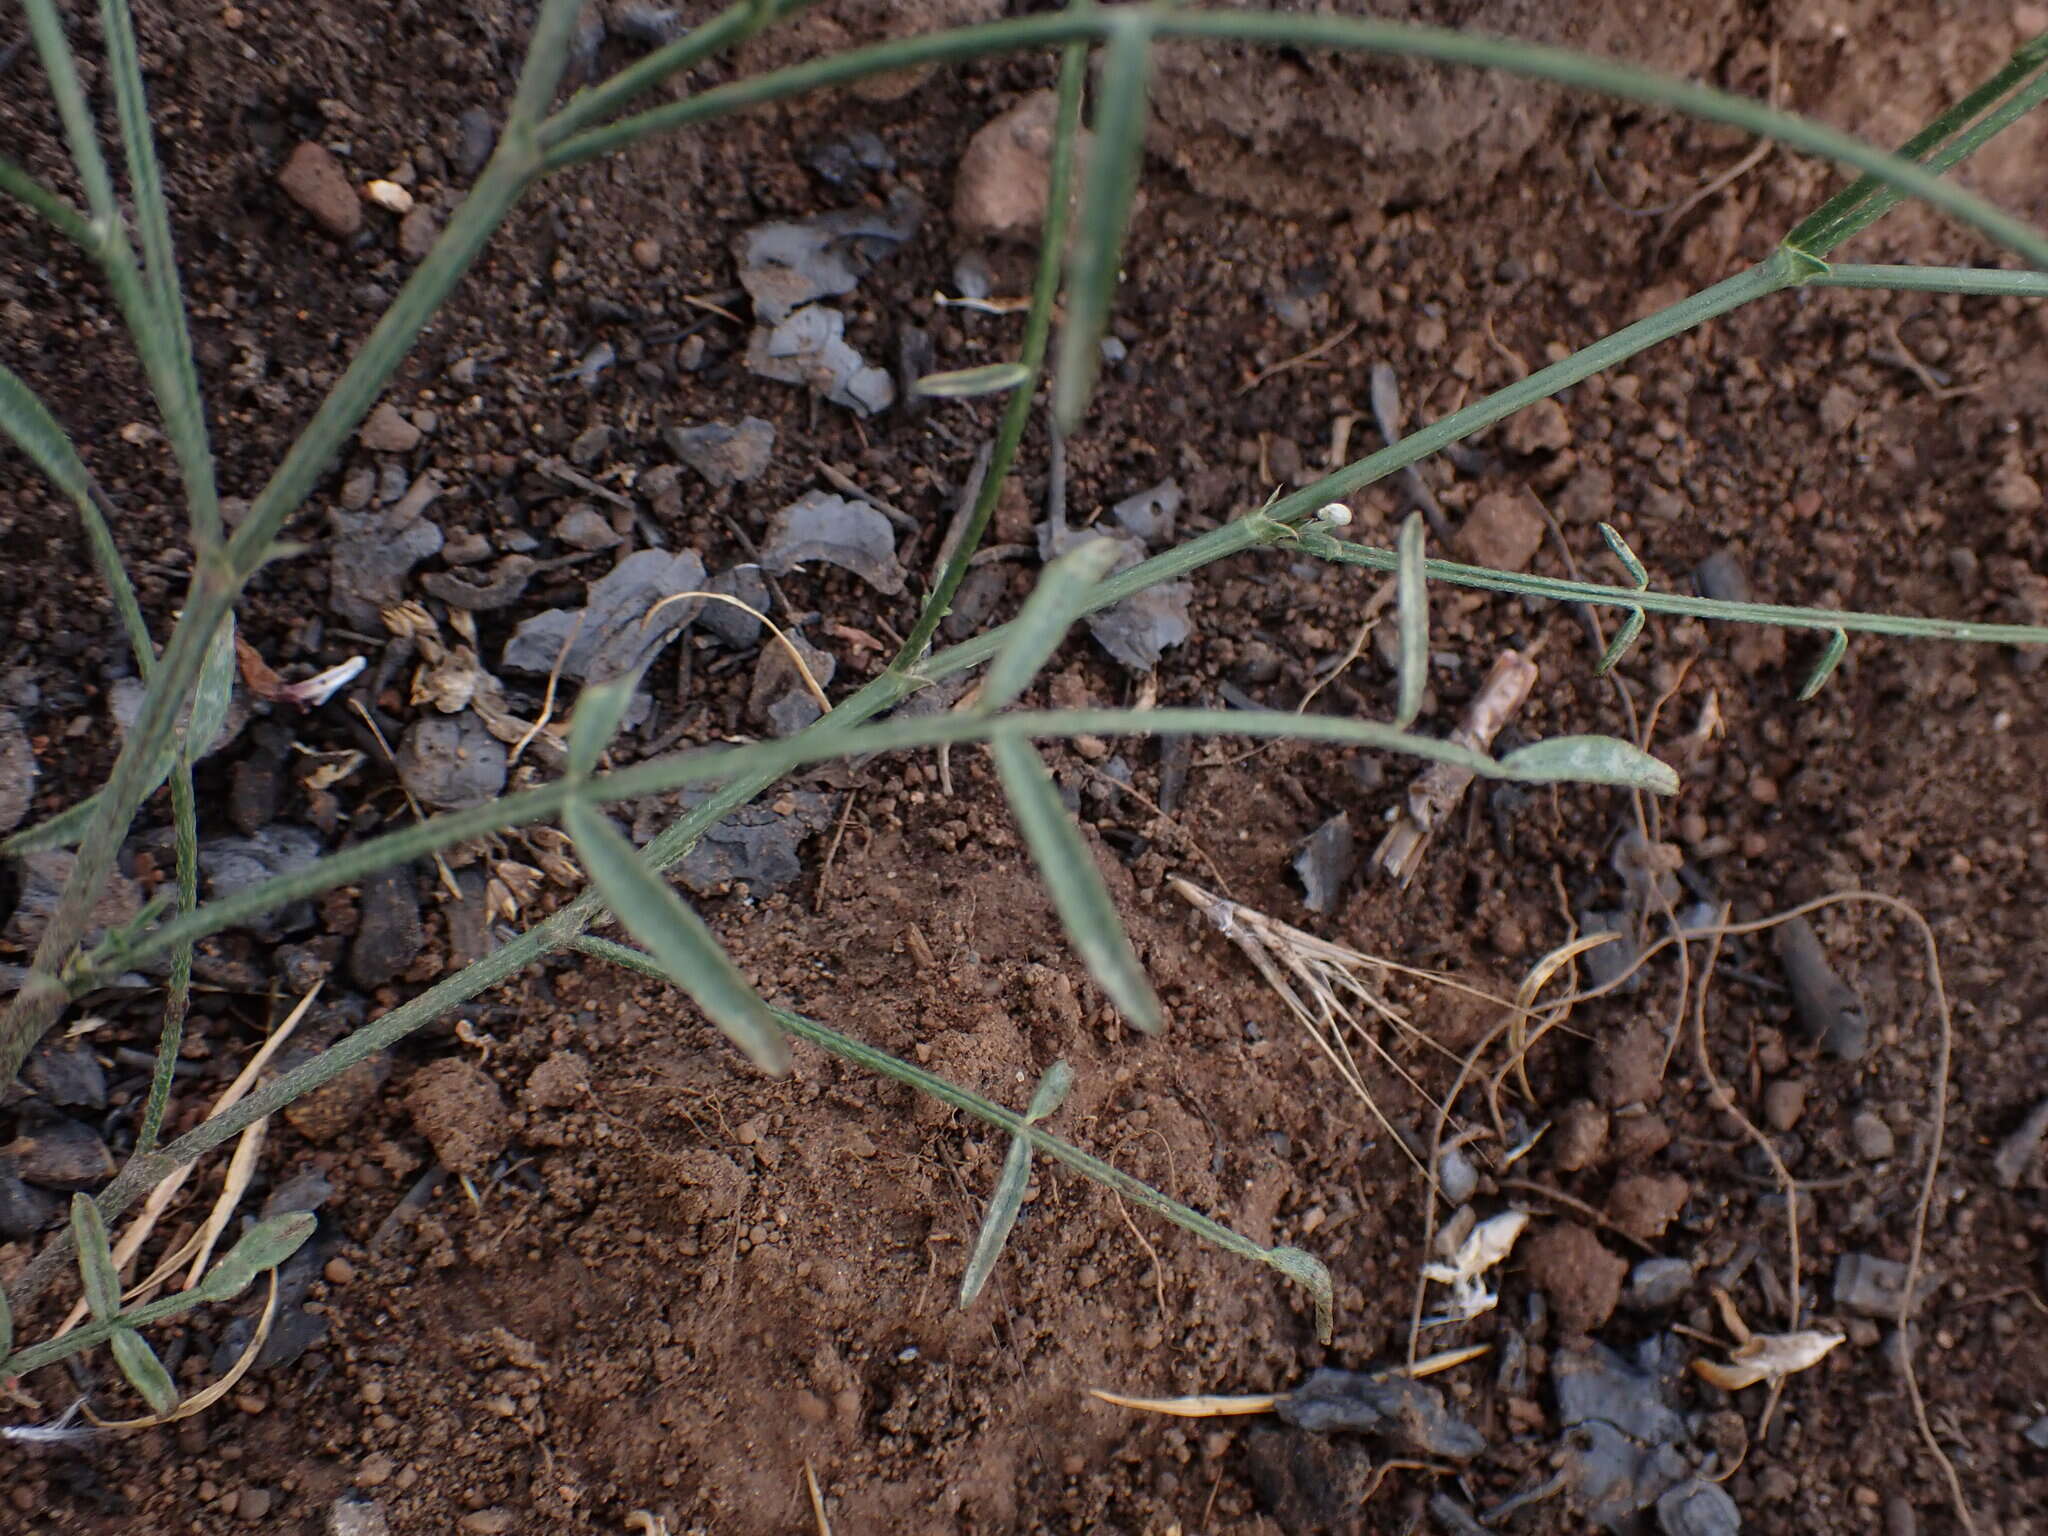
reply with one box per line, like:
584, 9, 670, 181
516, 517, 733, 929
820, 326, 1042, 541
0, 0, 2048, 1536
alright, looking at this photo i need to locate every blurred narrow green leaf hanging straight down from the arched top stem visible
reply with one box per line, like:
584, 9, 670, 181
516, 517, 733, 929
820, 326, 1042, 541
1053, 12, 1151, 432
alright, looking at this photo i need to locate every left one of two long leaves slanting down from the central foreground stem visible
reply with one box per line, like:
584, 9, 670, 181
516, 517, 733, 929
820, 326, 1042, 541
563, 799, 788, 1073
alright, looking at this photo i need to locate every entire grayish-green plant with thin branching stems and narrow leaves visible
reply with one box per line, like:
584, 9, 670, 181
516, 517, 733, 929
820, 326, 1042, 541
0, 0, 2048, 1407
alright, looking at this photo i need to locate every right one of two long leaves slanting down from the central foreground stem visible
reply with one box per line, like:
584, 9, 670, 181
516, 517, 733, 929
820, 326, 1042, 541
989, 735, 1161, 1034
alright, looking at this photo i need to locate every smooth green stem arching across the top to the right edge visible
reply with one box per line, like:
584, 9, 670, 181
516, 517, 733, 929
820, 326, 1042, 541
547, 6, 2048, 268
